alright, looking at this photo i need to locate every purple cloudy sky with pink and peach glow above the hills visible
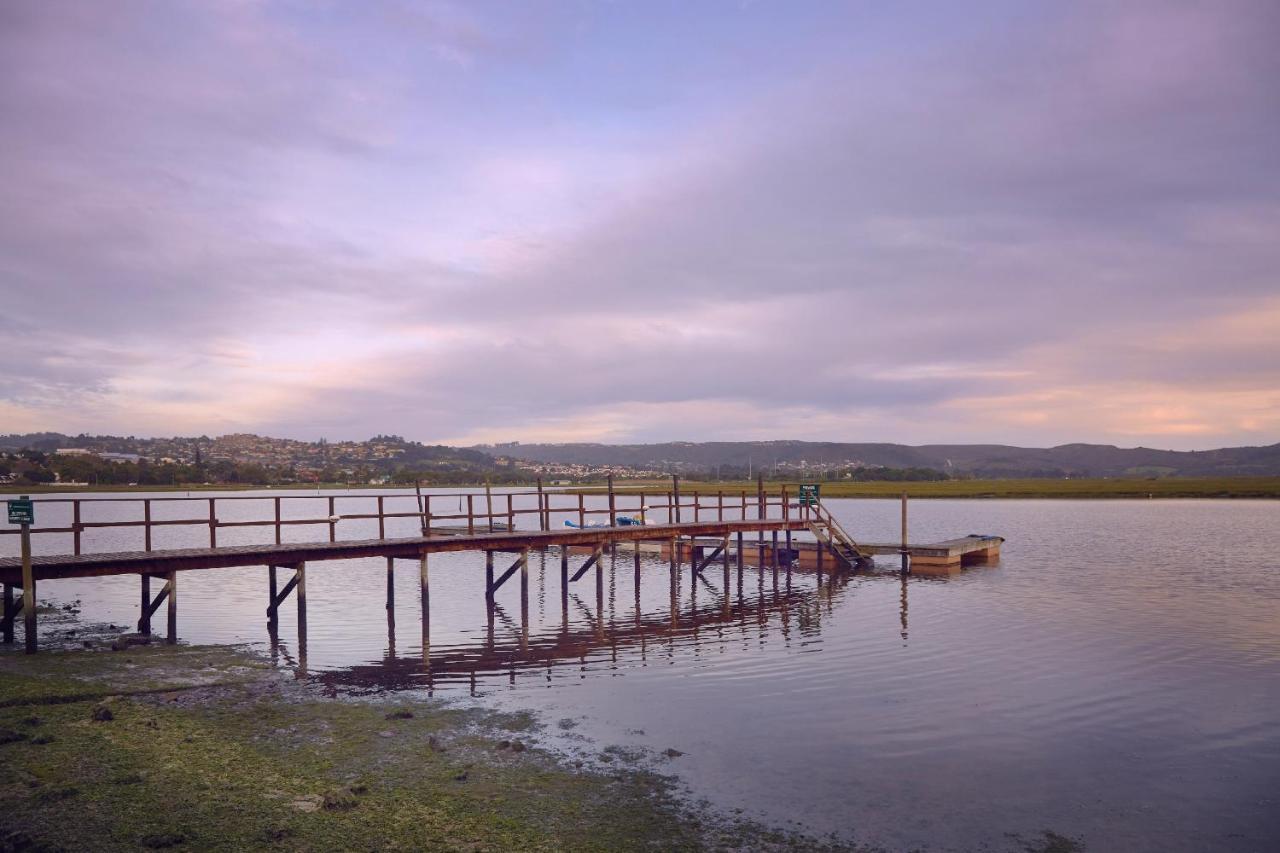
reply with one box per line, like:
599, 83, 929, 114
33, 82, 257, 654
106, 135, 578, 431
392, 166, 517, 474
0, 0, 1280, 450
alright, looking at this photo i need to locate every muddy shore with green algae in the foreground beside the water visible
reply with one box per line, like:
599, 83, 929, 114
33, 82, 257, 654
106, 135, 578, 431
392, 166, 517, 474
0, 622, 870, 850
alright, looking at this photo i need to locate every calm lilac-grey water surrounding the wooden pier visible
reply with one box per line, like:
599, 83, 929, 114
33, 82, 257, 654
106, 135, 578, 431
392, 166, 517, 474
0, 492, 1280, 850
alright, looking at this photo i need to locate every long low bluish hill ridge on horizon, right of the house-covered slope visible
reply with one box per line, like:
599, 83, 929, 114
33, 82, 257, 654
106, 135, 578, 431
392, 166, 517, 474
475, 441, 1280, 479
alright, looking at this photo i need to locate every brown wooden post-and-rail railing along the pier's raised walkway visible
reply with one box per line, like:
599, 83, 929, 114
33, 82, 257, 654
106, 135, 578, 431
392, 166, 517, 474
0, 482, 815, 555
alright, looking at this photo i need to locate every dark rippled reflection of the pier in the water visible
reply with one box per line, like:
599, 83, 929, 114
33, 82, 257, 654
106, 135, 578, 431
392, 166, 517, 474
270, 551, 880, 694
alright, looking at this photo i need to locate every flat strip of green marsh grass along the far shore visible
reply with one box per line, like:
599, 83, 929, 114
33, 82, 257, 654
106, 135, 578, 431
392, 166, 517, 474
10, 476, 1280, 500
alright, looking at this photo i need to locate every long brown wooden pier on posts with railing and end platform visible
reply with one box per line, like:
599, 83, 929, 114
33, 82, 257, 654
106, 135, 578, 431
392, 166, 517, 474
0, 478, 1002, 652
